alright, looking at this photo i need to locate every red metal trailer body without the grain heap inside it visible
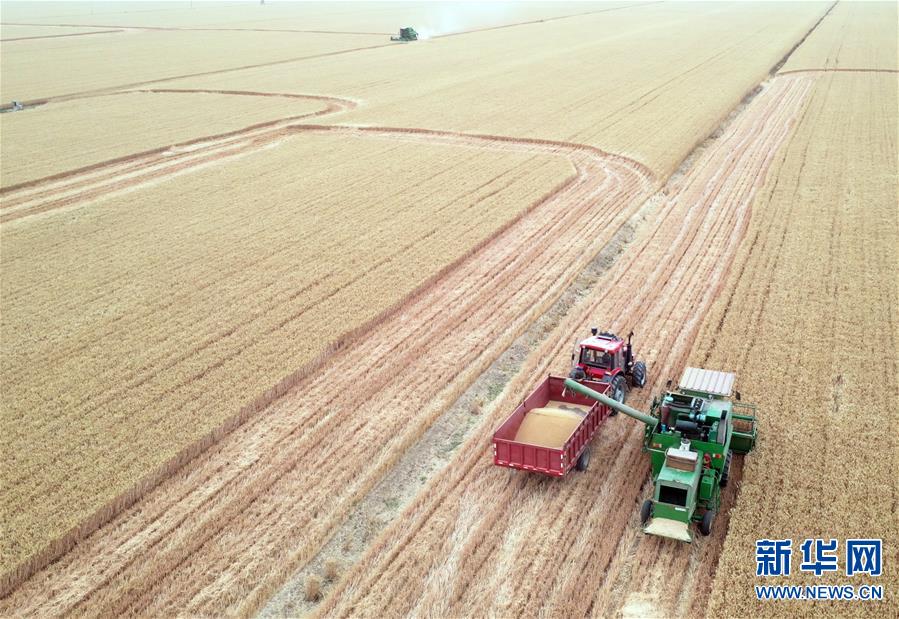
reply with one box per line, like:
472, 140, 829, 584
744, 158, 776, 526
493, 376, 612, 477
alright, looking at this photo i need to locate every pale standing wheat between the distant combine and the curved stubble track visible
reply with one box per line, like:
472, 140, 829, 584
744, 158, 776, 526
170, 3, 826, 178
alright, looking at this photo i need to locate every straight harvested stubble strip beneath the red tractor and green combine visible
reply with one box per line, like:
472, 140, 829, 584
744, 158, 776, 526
320, 77, 813, 616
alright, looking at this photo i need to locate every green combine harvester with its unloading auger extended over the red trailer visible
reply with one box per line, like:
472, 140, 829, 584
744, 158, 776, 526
565, 368, 756, 542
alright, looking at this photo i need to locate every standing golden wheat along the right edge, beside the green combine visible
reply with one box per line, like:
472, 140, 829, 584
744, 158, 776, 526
694, 13, 899, 616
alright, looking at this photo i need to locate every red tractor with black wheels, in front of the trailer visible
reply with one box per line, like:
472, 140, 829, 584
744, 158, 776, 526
568, 327, 646, 414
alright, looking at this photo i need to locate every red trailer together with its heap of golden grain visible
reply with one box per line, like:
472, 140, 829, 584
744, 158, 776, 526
493, 376, 612, 477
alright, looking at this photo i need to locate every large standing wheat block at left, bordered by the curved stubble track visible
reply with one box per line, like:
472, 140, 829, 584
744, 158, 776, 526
0, 135, 572, 600
